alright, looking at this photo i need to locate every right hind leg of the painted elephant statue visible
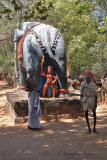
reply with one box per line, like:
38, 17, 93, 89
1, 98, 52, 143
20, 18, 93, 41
51, 32, 68, 88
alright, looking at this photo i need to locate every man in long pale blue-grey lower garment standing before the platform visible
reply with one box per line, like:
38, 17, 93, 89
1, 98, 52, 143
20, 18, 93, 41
25, 68, 42, 130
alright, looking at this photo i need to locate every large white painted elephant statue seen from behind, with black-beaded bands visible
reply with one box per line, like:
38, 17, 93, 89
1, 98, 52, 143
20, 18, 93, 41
14, 22, 67, 93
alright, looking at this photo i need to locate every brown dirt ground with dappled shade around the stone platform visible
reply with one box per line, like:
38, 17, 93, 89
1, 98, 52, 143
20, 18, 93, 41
0, 83, 107, 160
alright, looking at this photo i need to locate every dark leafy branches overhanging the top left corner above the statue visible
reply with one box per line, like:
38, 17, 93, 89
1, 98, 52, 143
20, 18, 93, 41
0, 0, 53, 21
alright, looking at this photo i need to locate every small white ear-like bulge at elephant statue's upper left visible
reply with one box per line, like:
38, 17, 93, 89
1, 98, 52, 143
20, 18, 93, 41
13, 29, 24, 42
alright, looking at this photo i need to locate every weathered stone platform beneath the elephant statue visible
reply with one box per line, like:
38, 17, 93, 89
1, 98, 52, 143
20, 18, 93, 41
6, 91, 82, 123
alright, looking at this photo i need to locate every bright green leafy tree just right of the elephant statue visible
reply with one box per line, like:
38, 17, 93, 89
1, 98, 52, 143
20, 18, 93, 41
49, 0, 98, 77
